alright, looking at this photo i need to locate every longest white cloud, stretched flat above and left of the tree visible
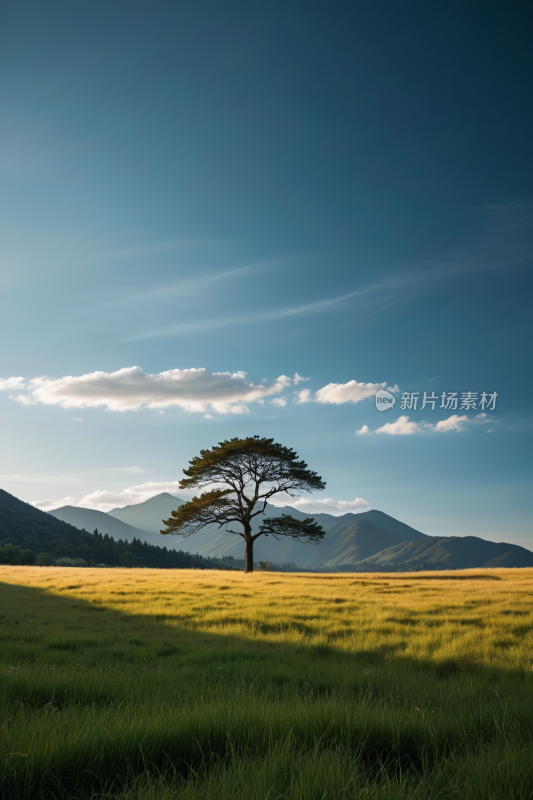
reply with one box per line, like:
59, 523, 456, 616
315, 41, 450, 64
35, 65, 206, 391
9, 367, 301, 414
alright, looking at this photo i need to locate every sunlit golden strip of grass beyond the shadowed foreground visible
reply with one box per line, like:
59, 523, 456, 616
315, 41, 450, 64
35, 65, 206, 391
0, 566, 533, 672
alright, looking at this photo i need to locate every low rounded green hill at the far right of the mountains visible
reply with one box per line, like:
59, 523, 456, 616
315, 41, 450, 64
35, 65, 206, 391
352, 536, 533, 572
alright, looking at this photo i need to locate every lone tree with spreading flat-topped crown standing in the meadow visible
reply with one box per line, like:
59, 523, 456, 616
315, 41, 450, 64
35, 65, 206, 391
161, 436, 326, 572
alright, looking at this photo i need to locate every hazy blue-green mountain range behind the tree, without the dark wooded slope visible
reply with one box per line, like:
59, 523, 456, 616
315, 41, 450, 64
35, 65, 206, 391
45, 492, 533, 572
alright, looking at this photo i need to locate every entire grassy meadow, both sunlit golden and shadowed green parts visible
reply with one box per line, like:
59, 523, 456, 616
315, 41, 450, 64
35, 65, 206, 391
0, 567, 533, 800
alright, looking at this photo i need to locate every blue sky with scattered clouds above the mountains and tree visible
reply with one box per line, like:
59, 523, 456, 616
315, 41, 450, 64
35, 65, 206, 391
0, 0, 533, 548
